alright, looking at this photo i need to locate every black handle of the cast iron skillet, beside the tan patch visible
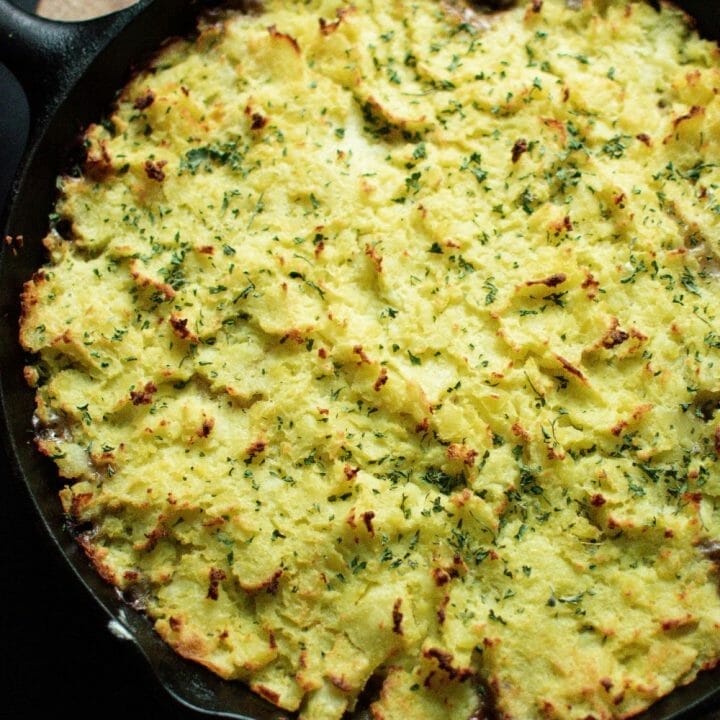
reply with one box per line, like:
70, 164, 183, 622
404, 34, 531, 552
0, 0, 151, 127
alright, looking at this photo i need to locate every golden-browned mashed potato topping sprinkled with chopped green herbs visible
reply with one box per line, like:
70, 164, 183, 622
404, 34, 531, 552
21, 0, 720, 720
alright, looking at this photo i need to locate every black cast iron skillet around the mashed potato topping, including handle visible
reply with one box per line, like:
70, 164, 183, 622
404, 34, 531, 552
0, 0, 720, 720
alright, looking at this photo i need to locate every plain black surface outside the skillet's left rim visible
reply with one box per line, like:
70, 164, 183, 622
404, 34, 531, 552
0, 59, 201, 720
